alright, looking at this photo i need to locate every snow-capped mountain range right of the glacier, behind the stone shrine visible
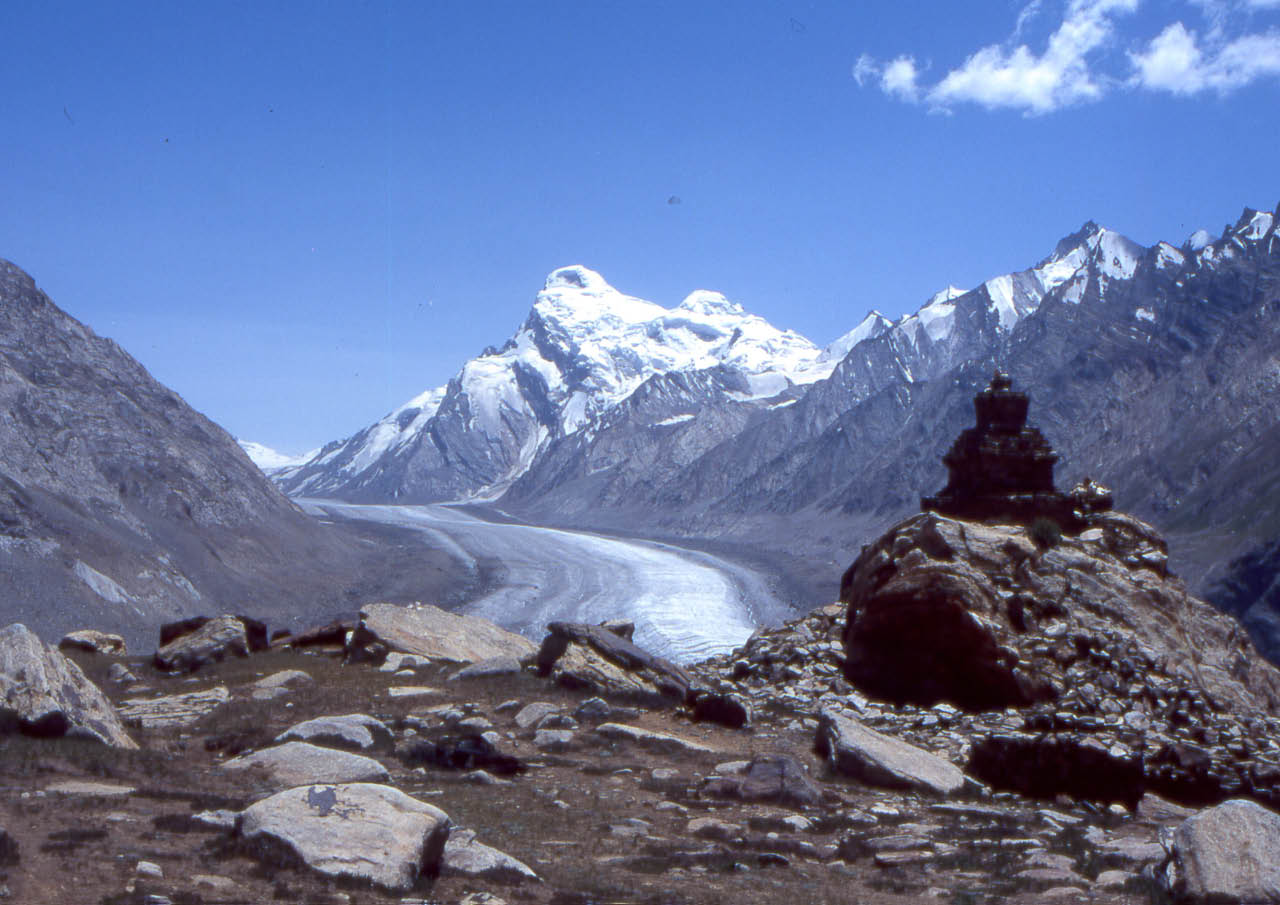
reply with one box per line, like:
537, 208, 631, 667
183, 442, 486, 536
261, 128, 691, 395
254, 209, 1280, 657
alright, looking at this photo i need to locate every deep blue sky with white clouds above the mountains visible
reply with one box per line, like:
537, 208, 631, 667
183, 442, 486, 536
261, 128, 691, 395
0, 0, 1280, 452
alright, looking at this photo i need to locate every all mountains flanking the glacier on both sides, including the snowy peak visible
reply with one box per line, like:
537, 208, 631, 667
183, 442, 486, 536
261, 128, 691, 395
0, 209, 1280, 657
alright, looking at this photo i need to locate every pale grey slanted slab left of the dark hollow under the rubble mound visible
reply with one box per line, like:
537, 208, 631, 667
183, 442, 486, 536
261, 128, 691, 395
817, 710, 965, 795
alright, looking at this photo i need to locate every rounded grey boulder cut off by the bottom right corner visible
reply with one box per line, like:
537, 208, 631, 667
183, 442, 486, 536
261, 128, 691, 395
1161, 799, 1280, 905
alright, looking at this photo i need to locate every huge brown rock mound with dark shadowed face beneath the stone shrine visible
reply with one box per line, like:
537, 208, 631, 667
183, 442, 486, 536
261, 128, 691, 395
841, 512, 1280, 805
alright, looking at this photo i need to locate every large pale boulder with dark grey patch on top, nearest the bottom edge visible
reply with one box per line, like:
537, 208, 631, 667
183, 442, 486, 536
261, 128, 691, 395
238, 782, 451, 892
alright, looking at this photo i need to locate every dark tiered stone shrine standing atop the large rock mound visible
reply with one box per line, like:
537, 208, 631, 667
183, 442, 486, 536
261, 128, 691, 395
920, 370, 1111, 531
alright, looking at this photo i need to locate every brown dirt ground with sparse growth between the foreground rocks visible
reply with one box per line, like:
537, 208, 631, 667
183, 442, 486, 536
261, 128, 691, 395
0, 652, 1149, 905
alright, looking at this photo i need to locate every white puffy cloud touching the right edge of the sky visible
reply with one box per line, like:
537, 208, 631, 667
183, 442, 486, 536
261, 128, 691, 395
1129, 22, 1280, 96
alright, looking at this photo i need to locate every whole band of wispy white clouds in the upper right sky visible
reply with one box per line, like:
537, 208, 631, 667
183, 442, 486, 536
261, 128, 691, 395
854, 0, 1280, 115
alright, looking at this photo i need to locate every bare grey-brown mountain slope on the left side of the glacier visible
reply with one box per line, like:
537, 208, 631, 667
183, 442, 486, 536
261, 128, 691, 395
0, 261, 407, 645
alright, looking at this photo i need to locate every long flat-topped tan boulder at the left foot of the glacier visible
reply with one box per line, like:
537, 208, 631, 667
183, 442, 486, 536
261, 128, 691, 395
349, 603, 535, 663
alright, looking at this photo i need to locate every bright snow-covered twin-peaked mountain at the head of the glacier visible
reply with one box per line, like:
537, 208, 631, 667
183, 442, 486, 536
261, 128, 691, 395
279, 265, 837, 501
